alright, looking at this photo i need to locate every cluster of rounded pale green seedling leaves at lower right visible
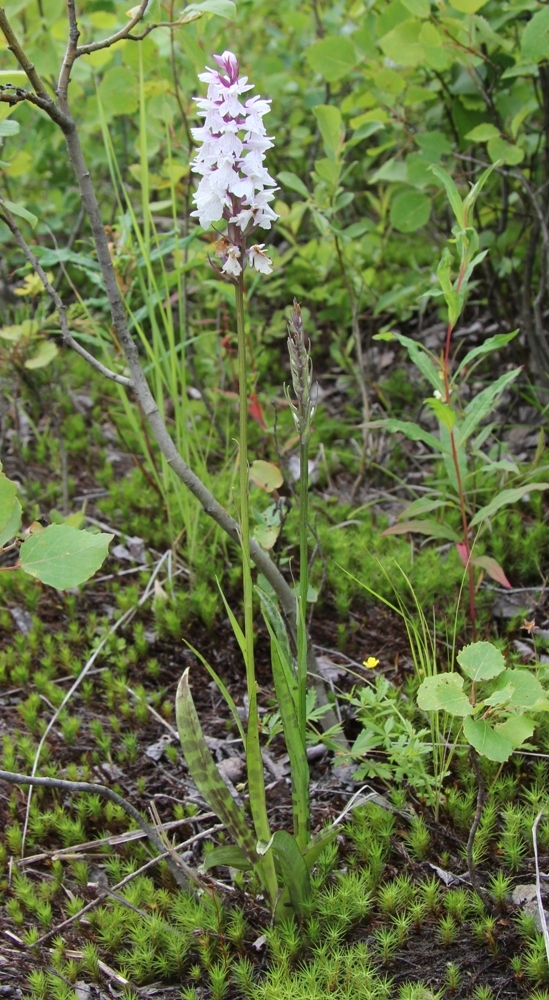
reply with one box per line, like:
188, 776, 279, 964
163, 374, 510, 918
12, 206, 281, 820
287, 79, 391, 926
417, 642, 549, 763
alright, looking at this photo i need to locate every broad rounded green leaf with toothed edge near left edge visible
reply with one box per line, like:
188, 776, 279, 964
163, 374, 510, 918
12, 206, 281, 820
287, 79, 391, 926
19, 524, 114, 590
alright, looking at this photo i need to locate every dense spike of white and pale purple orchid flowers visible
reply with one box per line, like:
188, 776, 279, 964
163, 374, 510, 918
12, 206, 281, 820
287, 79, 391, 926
191, 51, 278, 238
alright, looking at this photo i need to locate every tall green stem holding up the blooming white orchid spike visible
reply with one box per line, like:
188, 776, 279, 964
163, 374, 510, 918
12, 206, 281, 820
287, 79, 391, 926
235, 275, 278, 906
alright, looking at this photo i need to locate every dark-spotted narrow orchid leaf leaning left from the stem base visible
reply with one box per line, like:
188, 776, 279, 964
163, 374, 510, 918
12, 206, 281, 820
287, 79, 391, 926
175, 668, 258, 867
